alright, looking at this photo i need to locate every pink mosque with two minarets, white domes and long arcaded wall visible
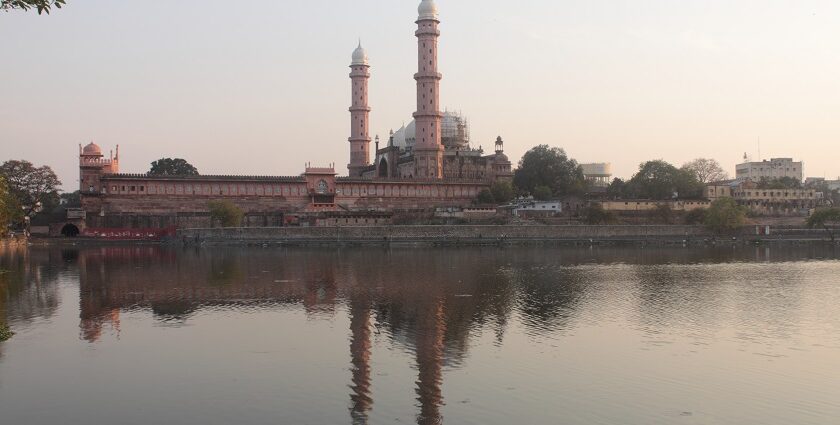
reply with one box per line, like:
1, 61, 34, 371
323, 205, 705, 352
68, 0, 513, 231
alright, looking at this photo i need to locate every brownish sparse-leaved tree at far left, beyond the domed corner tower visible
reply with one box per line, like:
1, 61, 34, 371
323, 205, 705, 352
0, 160, 61, 216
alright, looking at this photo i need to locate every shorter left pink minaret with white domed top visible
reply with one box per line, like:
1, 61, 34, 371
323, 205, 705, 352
347, 42, 370, 177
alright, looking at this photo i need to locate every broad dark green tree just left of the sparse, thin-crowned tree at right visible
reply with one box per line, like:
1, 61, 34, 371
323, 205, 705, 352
626, 160, 704, 200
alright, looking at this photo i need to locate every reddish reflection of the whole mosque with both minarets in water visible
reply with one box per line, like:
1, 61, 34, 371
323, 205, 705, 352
78, 247, 512, 424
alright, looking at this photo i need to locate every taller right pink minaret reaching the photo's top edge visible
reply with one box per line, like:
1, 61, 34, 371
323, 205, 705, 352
414, 0, 443, 179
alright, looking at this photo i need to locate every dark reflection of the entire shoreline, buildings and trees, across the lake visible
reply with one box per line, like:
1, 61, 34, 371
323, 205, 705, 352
0, 246, 838, 424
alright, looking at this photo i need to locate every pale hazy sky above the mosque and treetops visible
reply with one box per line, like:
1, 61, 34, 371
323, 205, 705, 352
0, 0, 840, 188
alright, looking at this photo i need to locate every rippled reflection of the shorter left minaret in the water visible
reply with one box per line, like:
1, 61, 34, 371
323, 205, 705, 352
350, 300, 373, 424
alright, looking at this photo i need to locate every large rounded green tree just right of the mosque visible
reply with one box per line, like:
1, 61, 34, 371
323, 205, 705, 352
513, 145, 586, 197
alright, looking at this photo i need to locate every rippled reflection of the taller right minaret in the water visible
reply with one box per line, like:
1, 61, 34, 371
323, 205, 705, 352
417, 300, 446, 425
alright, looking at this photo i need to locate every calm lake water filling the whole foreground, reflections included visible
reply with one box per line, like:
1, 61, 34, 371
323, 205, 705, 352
0, 243, 840, 425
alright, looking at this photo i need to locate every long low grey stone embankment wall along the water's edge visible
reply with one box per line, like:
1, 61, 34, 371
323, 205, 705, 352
178, 226, 711, 243
